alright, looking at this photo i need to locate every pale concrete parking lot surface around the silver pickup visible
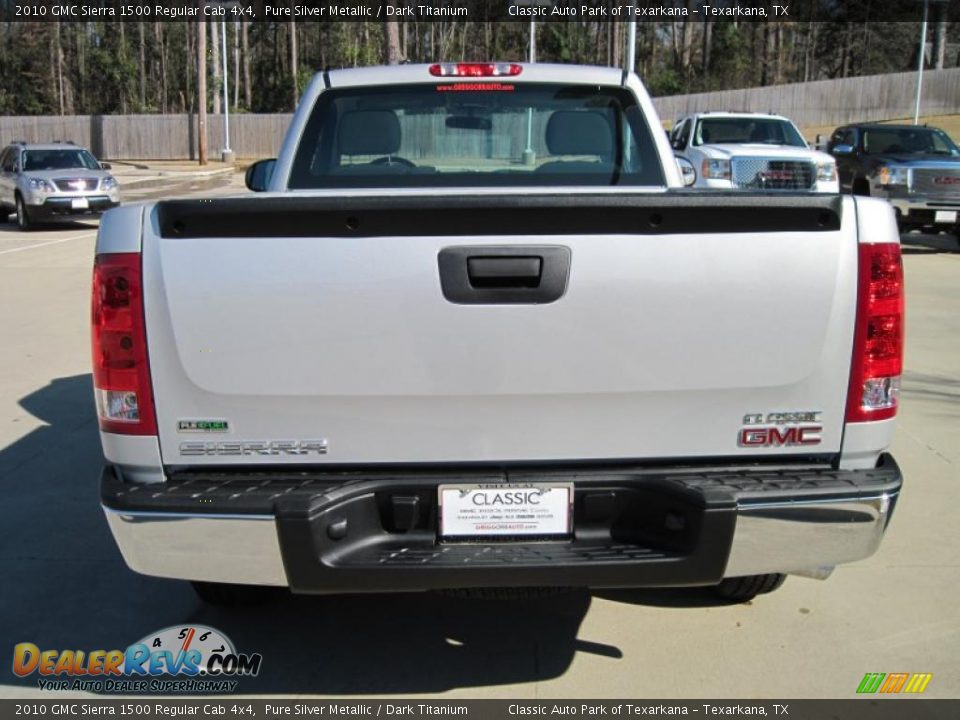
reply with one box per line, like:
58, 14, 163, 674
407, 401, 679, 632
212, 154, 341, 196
0, 177, 960, 698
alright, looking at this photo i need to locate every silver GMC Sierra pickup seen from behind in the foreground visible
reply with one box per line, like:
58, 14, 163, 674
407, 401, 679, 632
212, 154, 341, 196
92, 63, 903, 602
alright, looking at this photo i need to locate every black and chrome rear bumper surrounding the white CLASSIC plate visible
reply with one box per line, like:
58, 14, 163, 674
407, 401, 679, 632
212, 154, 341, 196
101, 455, 902, 593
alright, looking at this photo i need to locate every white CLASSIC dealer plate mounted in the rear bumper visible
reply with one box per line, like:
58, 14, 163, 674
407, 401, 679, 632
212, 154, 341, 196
439, 483, 573, 539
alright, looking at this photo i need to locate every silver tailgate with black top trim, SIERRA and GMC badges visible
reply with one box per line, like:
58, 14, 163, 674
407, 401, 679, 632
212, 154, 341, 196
143, 191, 857, 466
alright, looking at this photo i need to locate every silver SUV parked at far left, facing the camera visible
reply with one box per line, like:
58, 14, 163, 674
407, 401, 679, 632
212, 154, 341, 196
0, 142, 120, 230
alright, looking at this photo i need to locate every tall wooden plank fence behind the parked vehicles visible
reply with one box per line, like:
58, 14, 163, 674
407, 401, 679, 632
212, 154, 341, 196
0, 68, 960, 160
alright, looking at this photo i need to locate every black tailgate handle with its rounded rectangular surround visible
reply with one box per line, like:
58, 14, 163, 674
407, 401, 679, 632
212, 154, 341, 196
437, 245, 570, 305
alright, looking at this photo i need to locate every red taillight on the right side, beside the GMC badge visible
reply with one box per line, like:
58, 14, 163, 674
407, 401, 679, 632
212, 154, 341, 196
847, 243, 904, 422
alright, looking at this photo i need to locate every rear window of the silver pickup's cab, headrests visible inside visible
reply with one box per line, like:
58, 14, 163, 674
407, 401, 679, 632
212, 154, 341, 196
289, 81, 664, 189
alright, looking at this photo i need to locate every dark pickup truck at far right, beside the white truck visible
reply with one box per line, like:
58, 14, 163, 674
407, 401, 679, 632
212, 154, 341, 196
827, 124, 960, 234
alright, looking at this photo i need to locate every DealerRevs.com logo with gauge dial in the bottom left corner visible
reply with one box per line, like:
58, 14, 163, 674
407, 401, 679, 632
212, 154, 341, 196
13, 625, 263, 693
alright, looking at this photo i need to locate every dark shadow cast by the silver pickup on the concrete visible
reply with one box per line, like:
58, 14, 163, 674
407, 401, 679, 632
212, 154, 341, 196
0, 375, 744, 695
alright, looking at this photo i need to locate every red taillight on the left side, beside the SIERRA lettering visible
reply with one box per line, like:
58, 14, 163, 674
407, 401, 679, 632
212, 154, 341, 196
90, 253, 157, 435
